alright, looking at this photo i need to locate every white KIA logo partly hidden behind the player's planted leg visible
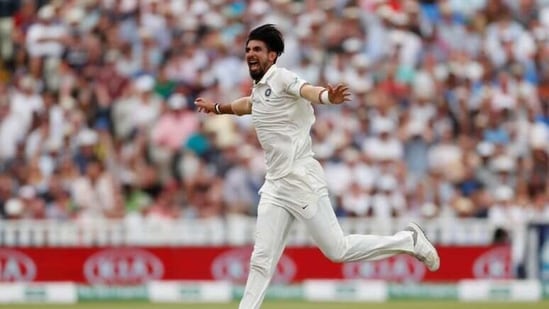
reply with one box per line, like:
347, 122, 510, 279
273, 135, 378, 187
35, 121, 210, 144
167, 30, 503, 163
212, 248, 296, 283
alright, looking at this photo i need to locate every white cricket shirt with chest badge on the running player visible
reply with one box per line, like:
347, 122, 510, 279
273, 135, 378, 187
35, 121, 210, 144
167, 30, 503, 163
251, 65, 315, 180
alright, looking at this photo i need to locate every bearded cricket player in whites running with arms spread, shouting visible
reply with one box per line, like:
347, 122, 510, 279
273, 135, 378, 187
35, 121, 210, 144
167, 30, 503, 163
195, 24, 440, 309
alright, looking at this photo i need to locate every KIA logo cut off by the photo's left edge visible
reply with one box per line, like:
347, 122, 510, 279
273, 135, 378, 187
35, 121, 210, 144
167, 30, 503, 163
0, 249, 36, 282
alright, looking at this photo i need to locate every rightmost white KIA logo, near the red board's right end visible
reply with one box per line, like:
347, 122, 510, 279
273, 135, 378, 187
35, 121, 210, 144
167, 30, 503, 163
473, 247, 512, 279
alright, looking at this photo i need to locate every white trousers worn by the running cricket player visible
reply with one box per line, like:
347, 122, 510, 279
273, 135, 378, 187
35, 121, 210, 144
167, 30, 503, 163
239, 195, 414, 309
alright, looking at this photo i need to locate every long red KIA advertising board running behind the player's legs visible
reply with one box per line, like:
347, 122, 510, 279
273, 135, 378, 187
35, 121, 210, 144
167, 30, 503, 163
0, 246, 512, 285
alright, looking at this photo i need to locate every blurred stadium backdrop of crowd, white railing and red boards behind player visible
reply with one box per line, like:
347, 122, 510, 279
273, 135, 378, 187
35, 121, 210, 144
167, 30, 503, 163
0, 0, 549, 308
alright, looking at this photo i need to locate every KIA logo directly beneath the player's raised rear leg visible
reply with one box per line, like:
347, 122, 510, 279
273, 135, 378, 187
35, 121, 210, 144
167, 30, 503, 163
343, 255, 425, 282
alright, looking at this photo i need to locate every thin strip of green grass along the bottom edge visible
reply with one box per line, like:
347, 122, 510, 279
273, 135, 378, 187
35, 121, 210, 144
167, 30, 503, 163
6, 300, 549, 309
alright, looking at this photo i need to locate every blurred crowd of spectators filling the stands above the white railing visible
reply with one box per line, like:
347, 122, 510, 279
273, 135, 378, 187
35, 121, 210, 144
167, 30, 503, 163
0, 0, 549, 233
